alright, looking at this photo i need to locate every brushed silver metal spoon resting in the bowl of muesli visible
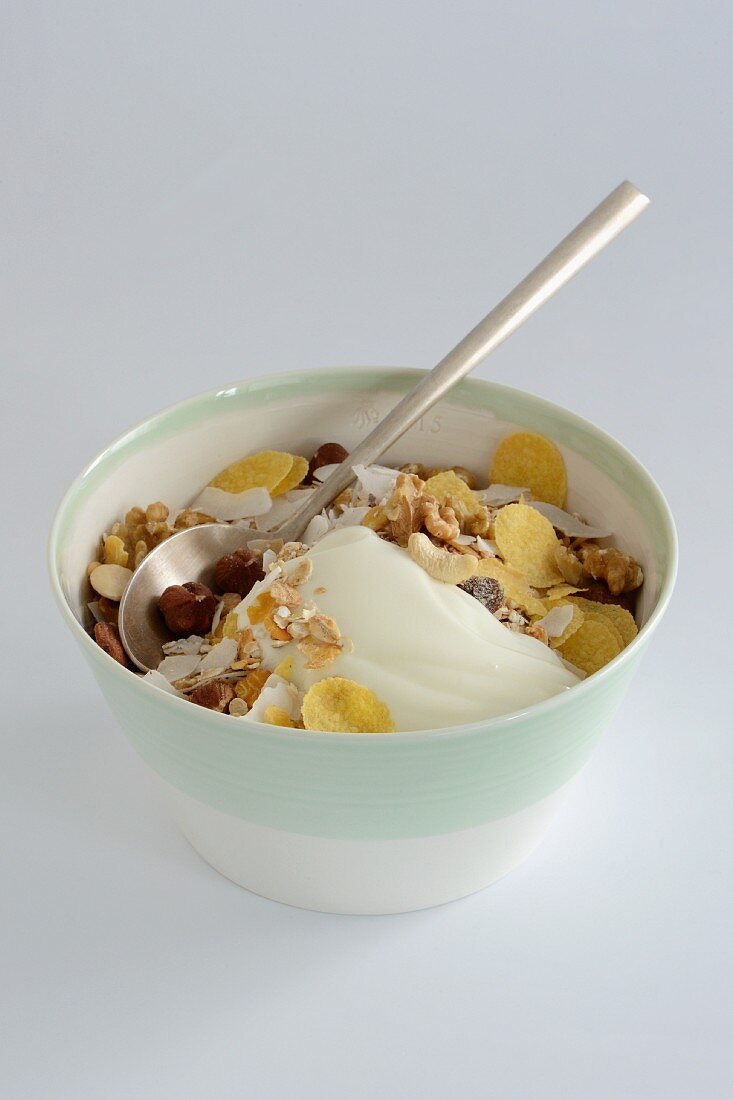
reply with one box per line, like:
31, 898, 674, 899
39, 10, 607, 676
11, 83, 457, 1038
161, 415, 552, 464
119, 180, 649, 671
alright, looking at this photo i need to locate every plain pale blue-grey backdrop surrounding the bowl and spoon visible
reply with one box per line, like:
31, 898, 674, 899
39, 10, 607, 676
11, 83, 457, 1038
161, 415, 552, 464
0, 0, 733, 1100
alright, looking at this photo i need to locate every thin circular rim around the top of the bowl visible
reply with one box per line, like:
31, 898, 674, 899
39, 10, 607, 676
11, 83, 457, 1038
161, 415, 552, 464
46, 365, 678, 744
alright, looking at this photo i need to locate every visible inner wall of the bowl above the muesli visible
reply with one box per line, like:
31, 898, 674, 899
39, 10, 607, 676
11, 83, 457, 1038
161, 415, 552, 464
51, 367, 675, 638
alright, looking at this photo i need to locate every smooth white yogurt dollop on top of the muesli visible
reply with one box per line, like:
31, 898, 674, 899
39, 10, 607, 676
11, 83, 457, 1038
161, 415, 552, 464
237, 527, 578, 730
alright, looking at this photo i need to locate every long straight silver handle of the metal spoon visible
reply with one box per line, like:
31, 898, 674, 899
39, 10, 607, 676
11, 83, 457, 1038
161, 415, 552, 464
273, 180, 649, 541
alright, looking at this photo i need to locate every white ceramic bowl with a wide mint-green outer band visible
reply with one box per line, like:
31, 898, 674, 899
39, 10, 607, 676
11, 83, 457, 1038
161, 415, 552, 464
50, 367, 677, 914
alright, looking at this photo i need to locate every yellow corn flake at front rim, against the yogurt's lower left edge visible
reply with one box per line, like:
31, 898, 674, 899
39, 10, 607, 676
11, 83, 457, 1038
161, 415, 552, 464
303, 677, 394, 734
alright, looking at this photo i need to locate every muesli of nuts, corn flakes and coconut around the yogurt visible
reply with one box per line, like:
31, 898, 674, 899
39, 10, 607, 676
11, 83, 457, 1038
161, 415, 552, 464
87, 431, 644, 733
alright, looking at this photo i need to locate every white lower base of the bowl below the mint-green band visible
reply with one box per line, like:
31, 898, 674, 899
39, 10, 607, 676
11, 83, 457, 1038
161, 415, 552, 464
156, 777, 570, 915
